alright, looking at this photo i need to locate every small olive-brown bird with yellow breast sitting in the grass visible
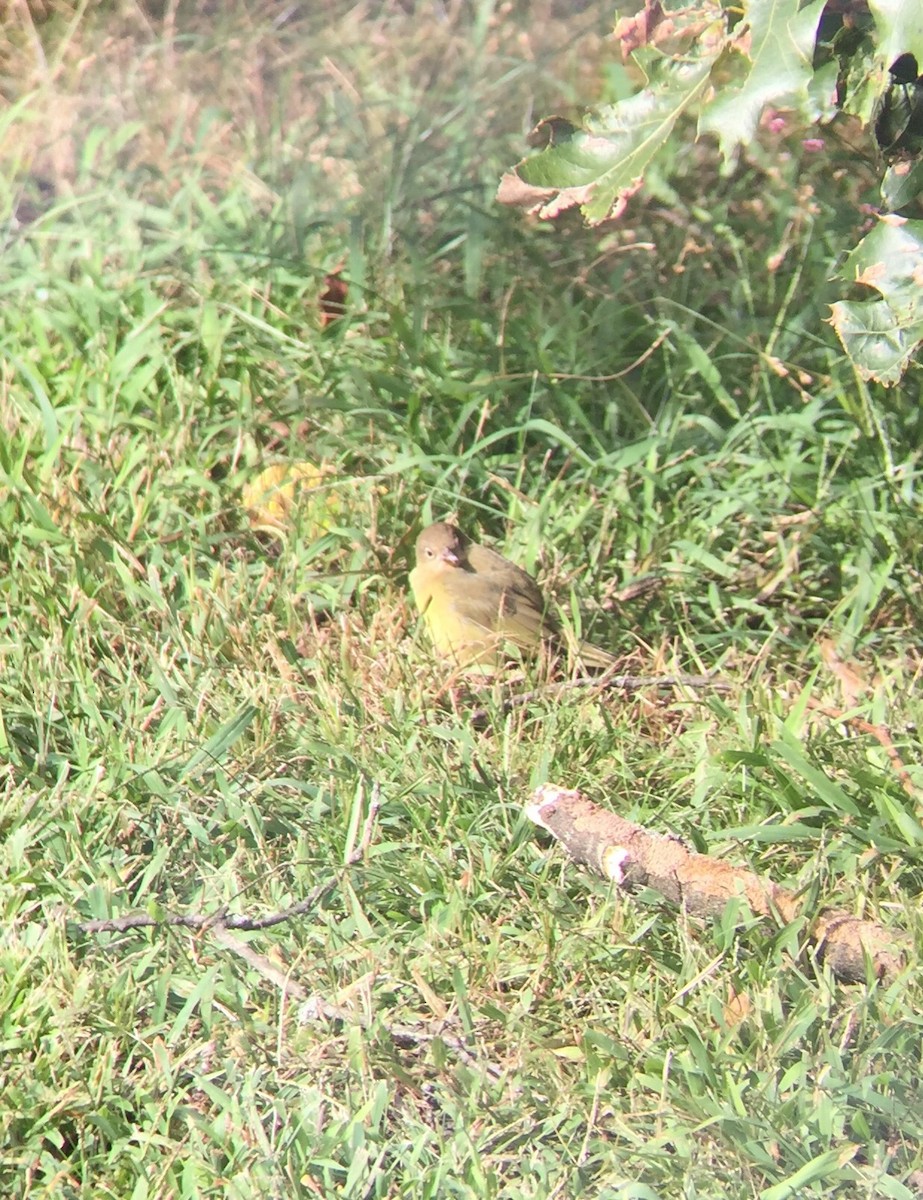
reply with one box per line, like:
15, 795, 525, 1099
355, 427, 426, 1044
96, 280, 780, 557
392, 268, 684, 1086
410, 521, 616, 670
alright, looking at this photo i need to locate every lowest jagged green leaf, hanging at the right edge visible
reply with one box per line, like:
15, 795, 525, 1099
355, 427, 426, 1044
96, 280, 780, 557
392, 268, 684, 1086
831, 217, 923, 384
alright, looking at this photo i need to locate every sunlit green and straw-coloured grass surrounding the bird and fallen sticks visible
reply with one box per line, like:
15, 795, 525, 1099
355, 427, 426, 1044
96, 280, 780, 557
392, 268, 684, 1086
0, 0, 923, 1200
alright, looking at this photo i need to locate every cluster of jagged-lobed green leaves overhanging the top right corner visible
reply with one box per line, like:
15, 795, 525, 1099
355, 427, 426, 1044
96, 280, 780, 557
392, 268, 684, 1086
498, 0, 923, 384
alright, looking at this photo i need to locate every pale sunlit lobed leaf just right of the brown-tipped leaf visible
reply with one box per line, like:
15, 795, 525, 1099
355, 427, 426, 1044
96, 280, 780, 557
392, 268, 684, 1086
699, 0, 825, 157
